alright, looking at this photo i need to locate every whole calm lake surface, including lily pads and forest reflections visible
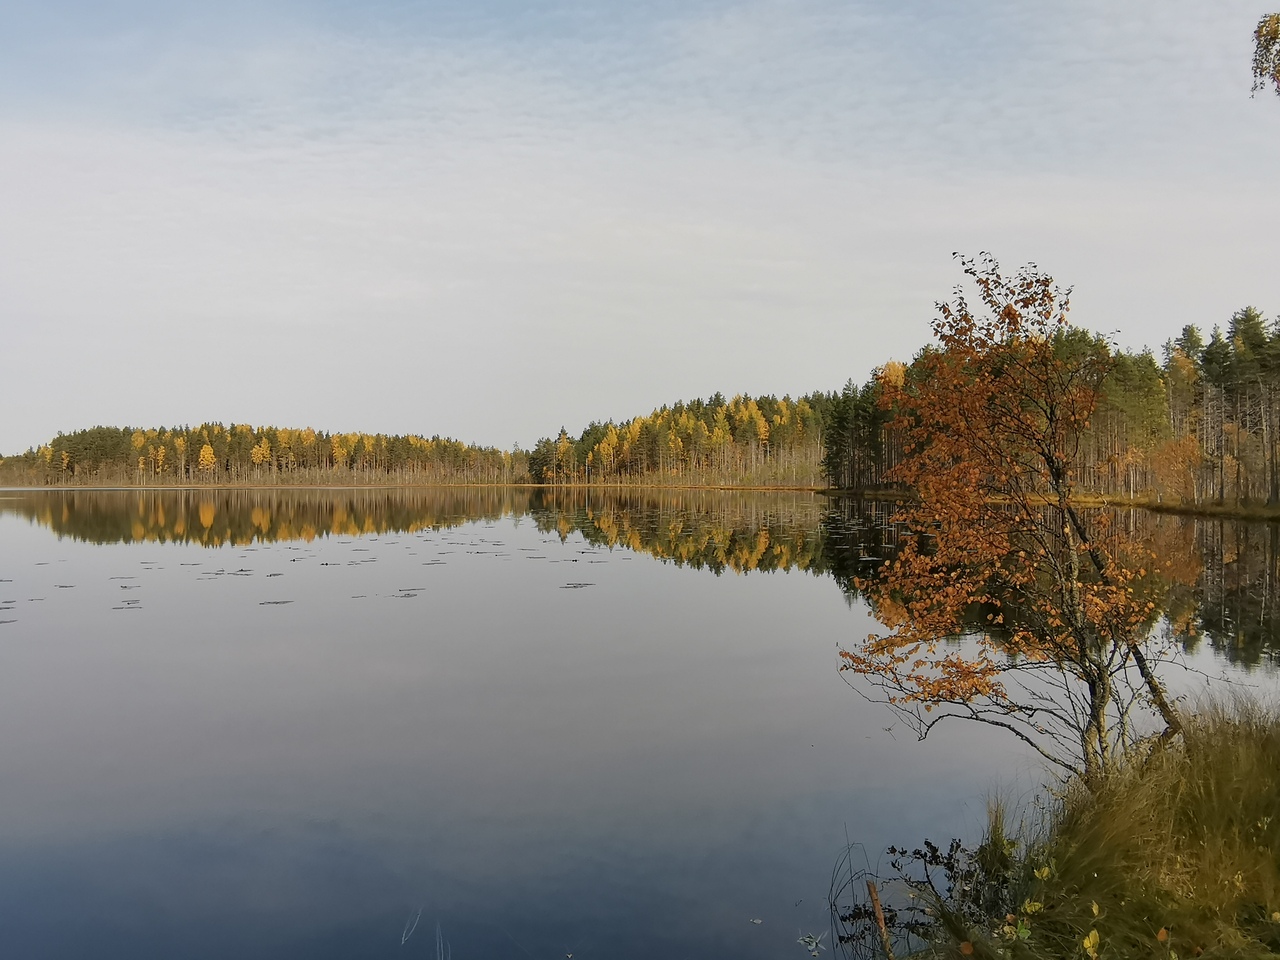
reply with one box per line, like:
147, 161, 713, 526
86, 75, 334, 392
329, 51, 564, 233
0, 489, 1277, 960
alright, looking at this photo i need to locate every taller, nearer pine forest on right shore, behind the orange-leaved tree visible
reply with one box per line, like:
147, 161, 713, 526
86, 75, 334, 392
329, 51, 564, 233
823, 307, 1280, 506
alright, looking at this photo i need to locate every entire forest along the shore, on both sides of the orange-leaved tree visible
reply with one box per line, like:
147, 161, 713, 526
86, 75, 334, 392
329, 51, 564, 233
0, 307, 1280, 504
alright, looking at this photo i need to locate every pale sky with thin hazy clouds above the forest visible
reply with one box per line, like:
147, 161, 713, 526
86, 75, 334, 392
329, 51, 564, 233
0, 0, 1280, 453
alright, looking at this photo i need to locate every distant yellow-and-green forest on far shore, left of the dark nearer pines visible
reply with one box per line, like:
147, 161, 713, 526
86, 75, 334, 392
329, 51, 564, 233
0, 394, 835, 488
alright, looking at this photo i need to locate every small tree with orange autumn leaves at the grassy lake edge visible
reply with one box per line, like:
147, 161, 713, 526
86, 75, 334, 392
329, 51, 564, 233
842, 255, 1180, 783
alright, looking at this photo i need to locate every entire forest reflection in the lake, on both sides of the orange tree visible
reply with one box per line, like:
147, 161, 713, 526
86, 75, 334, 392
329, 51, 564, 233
0, 486, 1280, 666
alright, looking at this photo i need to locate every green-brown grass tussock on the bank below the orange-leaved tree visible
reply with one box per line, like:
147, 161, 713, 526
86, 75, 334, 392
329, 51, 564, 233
849, 701, 1280, 960
